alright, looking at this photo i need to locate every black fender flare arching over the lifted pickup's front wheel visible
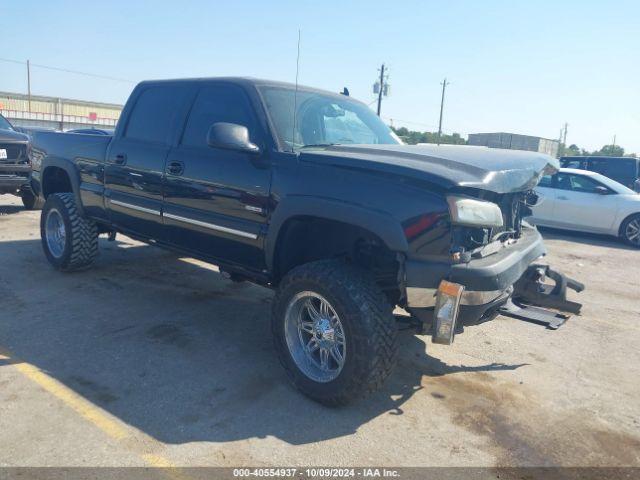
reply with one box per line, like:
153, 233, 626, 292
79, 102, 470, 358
265, 195, 409, 271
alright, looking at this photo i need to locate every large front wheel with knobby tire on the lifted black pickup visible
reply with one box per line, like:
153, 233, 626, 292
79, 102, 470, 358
271, 260, 397, 406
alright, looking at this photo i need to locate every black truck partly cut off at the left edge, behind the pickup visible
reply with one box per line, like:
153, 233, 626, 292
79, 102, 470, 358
0, 115, 36, 210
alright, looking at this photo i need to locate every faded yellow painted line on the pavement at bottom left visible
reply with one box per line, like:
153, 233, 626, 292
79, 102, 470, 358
0, 347, 184, 478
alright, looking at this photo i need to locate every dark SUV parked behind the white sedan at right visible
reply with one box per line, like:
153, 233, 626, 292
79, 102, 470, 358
560, 156, 640, 192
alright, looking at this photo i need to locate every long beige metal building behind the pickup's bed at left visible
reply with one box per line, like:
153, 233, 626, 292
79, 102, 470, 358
0, 92, 122, 130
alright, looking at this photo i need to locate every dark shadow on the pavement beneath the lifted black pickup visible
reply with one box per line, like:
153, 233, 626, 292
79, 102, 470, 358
0, 240, 523, 445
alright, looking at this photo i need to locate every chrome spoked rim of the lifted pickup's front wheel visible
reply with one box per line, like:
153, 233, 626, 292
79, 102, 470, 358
284, 292, 347, 383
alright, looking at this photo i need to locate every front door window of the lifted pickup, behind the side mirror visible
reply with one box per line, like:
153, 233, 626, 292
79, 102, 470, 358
181, 85, 255, 147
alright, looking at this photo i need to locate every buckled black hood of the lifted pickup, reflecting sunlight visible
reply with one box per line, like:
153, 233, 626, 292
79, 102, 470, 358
300, 145, 560, 194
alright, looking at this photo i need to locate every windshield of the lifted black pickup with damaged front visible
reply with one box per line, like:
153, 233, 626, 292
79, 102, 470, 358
260, 87, 400, 151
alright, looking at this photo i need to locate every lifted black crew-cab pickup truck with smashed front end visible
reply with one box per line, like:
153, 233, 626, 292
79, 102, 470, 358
32, 78, 558, 405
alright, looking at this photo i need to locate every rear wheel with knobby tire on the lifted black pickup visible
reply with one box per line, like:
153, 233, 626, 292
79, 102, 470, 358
40, 193, 98, 272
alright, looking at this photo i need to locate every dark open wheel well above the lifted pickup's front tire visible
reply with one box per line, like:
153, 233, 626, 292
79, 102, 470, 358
273, 216, 400, 302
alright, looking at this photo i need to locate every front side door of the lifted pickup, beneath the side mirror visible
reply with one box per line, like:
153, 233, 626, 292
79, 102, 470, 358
163, 82, 271, 270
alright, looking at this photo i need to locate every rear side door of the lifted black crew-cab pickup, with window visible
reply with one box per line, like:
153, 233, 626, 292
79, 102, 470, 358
104, 83, 188, 239
